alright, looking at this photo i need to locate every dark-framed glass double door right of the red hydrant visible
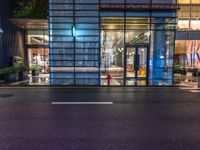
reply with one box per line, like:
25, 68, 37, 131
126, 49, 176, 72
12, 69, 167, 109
126, 46, 149, 86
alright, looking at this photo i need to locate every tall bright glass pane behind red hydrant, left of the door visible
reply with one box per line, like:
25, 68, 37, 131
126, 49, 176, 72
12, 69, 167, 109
101, 30, 124, 85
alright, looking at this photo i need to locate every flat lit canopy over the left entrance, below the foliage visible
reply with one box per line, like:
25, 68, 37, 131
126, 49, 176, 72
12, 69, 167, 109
10, 18, 49, 30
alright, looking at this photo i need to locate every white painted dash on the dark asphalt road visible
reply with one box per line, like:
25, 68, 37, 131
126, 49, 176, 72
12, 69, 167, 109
51, 102, 113, 105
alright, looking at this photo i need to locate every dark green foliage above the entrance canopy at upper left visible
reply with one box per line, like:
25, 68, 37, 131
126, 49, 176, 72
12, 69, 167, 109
13, 0, 48, 19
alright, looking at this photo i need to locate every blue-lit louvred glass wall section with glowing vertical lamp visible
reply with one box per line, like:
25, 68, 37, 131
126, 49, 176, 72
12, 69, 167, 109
49, 0, 100, 85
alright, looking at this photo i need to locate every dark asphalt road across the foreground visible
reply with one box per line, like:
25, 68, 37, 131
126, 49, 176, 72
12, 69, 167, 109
0, 87, 200, 150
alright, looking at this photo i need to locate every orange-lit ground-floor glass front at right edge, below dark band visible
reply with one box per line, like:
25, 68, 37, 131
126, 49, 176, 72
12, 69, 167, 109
174, 40, 200, 86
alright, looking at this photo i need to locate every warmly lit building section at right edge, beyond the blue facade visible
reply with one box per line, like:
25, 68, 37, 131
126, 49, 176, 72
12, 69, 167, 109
174, 0, 200, 86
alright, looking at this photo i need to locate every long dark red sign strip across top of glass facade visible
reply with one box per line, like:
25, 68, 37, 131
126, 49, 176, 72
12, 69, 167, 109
100, 3, 179, 10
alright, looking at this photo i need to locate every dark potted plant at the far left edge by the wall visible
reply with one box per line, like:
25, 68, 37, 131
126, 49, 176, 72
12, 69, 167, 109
2, 67, 19, 82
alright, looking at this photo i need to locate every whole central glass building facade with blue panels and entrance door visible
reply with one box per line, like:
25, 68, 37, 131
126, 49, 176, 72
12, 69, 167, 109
49, 0, 178, 86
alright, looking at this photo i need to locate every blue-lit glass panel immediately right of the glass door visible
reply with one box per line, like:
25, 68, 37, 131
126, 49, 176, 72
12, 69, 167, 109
150, 30, 175, 85
